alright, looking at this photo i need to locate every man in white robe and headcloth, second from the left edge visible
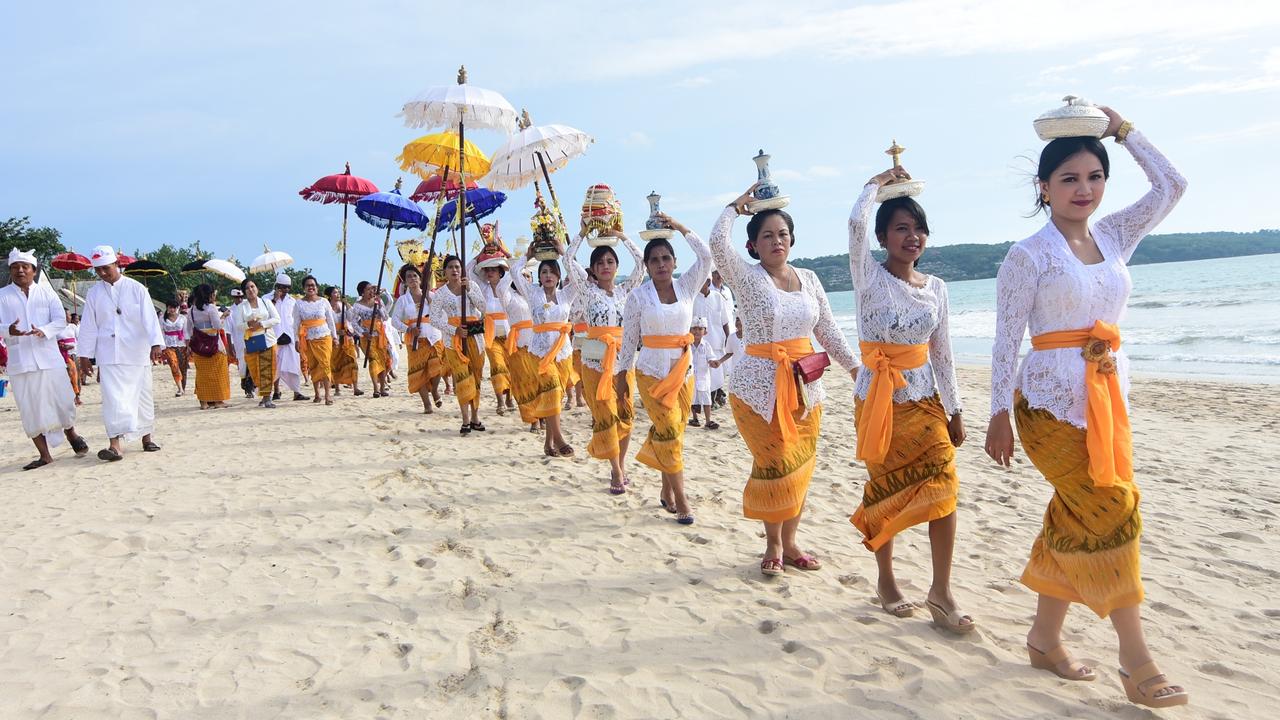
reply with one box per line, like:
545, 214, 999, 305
79, 245, 164, 461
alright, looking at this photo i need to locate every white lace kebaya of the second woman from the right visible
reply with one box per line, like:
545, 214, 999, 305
849, 182, 961, 416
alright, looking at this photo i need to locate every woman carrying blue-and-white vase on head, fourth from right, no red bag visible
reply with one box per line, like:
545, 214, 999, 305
613, 214, 712, 525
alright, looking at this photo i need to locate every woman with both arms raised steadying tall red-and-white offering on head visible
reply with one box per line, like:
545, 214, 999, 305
566, 228, 644, 495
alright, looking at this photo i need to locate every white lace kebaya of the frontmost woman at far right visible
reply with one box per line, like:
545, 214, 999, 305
991, 129, 1187, 428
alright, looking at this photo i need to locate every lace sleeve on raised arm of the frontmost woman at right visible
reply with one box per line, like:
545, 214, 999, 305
1096, 131, 1187, 263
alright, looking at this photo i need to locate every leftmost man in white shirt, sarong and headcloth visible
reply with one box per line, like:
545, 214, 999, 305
0, 247, 88, 470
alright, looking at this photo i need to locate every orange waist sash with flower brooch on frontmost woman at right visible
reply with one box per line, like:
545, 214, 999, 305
1032, 320, 1133, 487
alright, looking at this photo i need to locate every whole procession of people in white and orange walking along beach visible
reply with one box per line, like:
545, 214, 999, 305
0, 101, 1188, 707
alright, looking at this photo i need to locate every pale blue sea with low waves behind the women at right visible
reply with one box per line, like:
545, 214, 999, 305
829, 255, 1280, 383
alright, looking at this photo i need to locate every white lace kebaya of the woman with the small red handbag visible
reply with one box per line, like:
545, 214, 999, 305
698, 208, 861, 423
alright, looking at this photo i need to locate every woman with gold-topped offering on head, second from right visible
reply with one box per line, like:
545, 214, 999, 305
849, 168, 975, 633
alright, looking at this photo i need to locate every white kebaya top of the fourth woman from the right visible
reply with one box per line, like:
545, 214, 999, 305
614, 231, 712, 380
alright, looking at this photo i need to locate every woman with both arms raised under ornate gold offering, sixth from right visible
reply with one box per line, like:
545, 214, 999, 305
507, 240, 577, 457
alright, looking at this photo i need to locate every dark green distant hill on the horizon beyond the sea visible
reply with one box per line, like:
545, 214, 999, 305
791, 229, 1280, 292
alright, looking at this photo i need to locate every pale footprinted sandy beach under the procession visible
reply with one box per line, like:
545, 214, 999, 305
0, 368, 1280, 720
